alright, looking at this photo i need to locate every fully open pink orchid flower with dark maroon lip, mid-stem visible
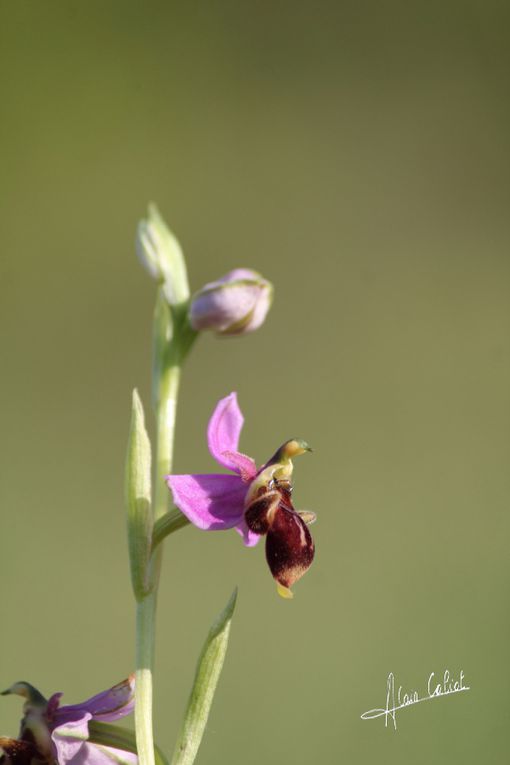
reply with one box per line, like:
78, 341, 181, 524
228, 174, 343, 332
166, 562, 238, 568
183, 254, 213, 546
166, 393, 315, 598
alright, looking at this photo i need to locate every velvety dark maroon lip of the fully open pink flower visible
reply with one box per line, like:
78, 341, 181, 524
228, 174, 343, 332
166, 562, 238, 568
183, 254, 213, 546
245, 481, 315, 588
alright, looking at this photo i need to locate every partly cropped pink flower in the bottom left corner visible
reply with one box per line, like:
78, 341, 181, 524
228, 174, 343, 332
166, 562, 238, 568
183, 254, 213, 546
0, 675, 138, 765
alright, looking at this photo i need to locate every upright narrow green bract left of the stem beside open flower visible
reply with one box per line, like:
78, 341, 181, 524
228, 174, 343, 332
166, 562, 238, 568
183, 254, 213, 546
126, 389, 153, 600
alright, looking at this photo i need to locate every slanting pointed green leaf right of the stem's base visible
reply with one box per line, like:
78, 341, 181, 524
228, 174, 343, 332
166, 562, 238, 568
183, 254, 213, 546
172, 588, 237, 765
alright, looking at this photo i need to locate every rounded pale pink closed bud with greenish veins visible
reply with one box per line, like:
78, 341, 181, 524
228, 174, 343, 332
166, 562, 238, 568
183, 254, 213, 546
190, 268, 273, 335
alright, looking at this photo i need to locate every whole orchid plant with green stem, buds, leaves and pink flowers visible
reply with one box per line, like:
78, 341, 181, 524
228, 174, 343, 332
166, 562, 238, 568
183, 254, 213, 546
0, 205, 315, 765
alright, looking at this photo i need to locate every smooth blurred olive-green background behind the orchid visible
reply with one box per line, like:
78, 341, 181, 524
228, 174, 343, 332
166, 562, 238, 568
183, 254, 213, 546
0, 0, 510, 765
